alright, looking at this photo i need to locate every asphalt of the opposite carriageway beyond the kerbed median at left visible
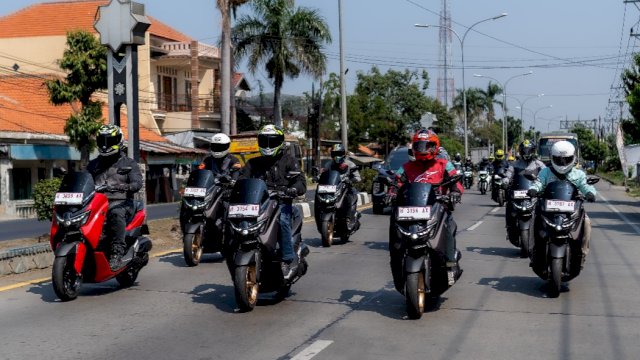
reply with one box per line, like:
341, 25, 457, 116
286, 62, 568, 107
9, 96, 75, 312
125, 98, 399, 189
0, 190, 315, 241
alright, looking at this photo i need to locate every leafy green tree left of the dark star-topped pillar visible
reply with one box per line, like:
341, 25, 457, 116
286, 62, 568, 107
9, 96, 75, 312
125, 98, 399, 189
45, 30, 107, 168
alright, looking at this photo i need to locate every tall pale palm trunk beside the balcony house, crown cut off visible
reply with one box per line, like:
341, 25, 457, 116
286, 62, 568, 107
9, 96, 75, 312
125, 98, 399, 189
216, 0, 249, 134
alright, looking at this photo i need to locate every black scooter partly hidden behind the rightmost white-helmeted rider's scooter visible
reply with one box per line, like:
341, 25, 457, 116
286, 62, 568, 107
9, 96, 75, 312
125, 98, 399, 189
507, 169, 538, 258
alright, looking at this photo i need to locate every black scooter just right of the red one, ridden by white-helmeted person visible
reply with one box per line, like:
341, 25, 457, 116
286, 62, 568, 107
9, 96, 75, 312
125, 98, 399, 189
180, 169, 227, 266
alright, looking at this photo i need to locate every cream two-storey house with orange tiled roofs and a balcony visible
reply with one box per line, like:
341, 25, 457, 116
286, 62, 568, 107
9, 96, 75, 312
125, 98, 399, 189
0, 0, 239, 214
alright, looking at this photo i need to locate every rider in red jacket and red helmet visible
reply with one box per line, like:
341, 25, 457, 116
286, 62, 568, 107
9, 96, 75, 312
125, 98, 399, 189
389, 130, 463, 292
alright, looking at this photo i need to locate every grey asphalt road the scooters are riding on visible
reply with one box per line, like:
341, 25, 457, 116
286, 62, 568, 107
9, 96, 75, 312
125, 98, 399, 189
0, 184, 640, 360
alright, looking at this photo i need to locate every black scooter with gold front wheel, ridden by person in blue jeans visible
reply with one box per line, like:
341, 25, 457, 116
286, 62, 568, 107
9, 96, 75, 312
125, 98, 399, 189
225, 174, 309, 311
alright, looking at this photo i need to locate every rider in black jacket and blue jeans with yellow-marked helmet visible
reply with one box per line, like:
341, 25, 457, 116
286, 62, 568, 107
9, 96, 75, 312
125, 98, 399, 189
240, 125, 307, 279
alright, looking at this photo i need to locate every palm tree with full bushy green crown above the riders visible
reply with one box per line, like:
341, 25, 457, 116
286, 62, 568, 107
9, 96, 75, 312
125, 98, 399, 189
233, 0, 331, 126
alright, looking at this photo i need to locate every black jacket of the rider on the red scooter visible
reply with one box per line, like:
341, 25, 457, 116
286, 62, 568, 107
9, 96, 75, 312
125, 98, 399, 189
87, 153, 142, 200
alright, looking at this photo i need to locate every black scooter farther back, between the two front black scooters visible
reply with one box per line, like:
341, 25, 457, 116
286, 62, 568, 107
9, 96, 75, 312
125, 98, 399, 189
314, 170, 359, 247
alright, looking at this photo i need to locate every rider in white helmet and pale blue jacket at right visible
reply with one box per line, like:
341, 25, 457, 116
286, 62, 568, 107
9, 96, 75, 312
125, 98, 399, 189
528, 141, 596, 267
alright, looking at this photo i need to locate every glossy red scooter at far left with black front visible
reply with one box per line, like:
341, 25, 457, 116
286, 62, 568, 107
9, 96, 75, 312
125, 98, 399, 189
50, 169, 151, 301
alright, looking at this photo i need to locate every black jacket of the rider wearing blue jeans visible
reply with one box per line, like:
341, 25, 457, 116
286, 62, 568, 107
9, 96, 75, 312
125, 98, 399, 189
240, 151, 307, 196
